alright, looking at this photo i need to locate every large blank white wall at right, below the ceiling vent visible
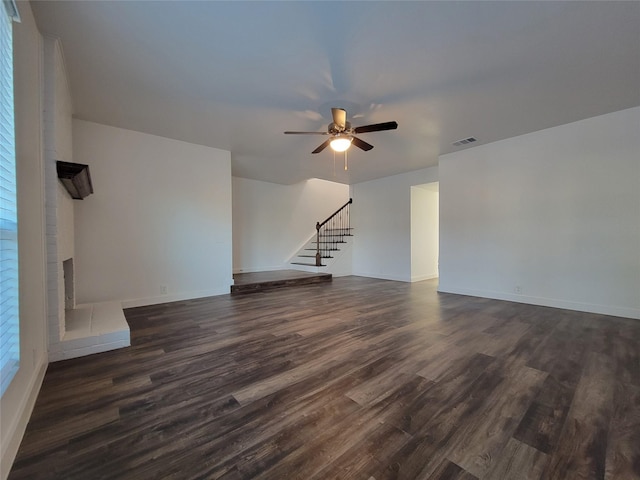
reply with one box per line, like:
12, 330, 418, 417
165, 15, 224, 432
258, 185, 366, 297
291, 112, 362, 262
440, 107, 640, 318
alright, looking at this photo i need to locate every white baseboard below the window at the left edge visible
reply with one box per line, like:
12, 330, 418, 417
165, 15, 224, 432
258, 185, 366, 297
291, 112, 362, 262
0, 361, 48, 480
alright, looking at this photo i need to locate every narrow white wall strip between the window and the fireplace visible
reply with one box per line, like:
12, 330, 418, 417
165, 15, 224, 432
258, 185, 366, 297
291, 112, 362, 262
0, 2, 47, 479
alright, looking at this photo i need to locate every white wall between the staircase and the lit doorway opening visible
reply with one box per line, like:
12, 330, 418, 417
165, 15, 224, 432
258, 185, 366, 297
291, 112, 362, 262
351, 167, 438, 282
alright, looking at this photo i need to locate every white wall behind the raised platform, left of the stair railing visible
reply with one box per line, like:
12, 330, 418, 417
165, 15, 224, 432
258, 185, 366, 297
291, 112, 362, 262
233, 177, 349, 272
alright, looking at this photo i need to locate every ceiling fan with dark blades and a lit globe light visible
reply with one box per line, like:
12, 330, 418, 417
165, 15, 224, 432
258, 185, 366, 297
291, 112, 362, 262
284, 108, 398, 153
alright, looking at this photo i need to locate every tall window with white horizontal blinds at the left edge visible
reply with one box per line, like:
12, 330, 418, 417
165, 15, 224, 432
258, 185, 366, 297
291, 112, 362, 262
0, 0, 20, 395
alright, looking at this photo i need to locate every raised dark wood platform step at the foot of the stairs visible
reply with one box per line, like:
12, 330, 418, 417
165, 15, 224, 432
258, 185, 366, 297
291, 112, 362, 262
231, 264, 332, 295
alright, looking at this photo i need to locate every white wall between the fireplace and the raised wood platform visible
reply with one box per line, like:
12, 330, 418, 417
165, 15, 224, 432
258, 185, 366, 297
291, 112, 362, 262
73, 120, 232, 307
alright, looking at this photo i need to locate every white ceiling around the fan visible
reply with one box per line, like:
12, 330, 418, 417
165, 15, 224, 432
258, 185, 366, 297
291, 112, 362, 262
32, 1, 640, 184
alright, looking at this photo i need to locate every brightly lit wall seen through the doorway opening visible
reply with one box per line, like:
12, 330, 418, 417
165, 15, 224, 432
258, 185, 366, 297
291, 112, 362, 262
411, 183, 439, 282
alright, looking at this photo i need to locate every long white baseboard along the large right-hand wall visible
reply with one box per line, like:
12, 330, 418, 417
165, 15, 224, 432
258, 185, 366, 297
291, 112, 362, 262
438, 284, 640, 320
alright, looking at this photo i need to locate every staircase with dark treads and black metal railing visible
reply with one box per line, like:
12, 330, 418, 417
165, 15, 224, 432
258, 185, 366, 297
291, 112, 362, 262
290, 199, 353, 271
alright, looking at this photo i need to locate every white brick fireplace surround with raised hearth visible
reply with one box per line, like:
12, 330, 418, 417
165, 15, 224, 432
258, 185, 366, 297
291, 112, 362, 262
43, 37, 131, 362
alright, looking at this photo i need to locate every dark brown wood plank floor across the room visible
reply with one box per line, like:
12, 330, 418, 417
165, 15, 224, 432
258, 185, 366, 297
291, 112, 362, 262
9, 277, 640, 480
